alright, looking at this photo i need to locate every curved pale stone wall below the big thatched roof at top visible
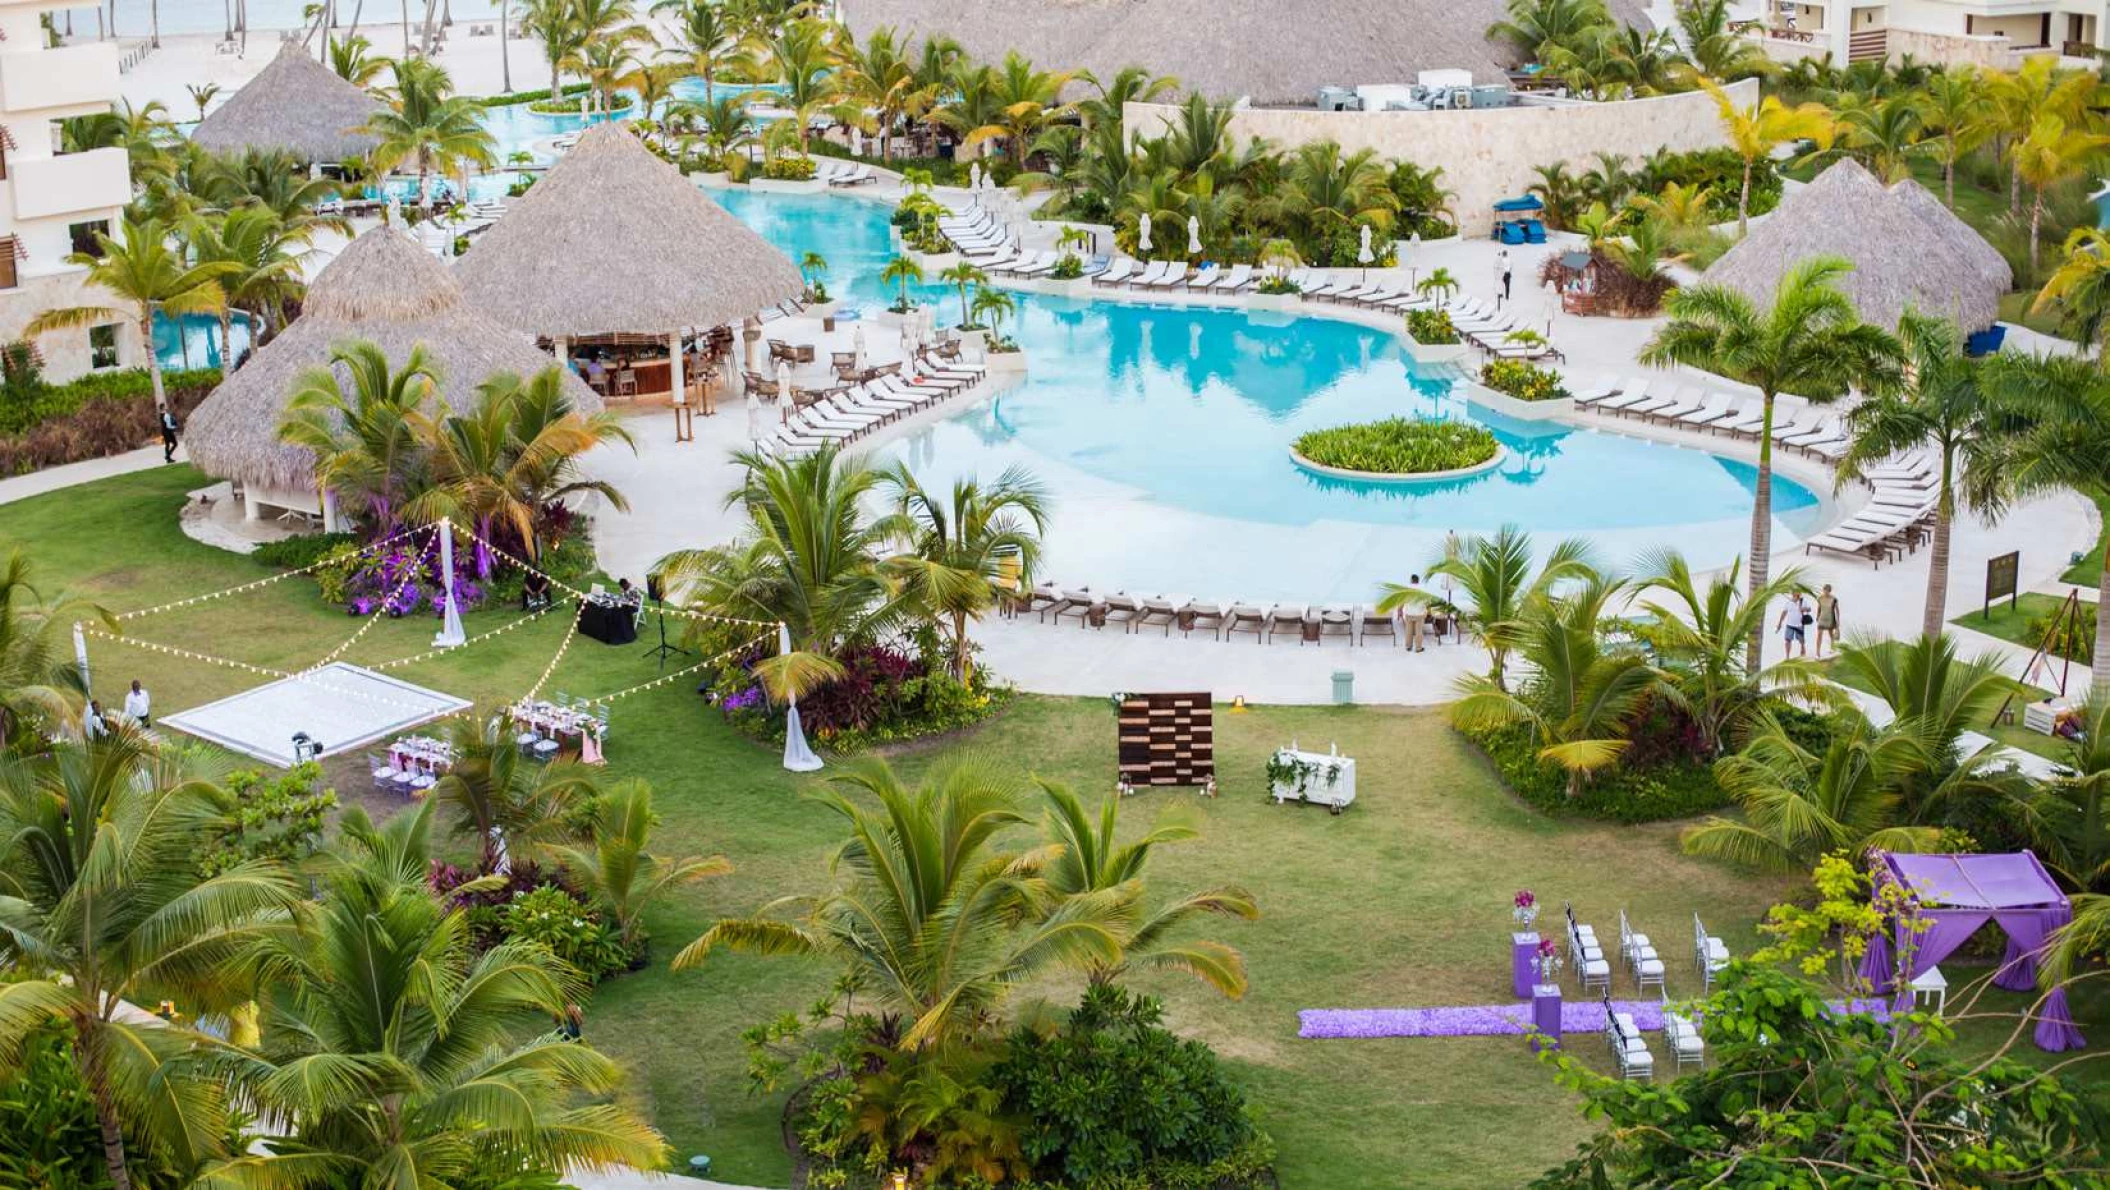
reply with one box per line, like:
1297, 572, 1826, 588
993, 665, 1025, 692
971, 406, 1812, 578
1123, 80, 1758, 234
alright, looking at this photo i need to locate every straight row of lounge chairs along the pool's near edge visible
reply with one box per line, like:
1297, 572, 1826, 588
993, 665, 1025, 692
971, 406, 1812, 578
1013, 582, 1452, 648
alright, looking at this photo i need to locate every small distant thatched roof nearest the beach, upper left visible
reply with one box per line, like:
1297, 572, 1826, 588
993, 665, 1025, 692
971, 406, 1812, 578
190, 42, 386, 160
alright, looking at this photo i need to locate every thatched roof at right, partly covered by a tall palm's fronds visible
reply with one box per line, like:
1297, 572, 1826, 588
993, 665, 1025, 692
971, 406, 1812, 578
1707, 160, 2013, 331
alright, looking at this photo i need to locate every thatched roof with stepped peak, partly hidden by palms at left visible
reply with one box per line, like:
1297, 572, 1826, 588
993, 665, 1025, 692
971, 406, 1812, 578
184, 228, 601, 487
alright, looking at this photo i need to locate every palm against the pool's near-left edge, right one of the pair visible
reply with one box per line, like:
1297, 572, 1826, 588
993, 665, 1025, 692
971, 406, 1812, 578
880, 464, 1049, 682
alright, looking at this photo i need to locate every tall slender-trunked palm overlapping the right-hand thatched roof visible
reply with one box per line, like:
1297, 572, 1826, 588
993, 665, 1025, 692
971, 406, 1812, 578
1642, 255, 1901, 671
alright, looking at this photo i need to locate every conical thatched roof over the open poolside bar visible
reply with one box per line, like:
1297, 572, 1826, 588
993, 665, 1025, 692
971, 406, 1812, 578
454, 122, 806, 338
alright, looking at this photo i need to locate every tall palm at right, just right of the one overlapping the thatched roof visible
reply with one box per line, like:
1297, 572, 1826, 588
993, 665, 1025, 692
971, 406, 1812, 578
1838, 310, 2009, 637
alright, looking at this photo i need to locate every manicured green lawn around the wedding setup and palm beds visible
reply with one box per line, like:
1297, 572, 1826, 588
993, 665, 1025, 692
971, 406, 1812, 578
0, 466, 2110, 1190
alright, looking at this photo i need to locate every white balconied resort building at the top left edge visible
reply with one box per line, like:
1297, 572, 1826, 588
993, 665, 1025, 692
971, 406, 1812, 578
0, 0, 143, 380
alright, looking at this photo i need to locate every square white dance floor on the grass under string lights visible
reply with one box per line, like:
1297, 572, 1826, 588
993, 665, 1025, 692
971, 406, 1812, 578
156, 660, 468, 768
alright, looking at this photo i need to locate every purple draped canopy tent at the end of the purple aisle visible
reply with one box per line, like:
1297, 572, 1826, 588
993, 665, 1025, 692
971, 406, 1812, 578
1861, 850, 2087, 1051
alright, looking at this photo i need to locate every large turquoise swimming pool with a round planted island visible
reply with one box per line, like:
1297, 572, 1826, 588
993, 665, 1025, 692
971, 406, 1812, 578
713, 190, 1823, 601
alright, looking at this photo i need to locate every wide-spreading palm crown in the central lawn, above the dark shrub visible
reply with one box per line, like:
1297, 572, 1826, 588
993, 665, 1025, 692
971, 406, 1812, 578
673, 757, 1133, 1051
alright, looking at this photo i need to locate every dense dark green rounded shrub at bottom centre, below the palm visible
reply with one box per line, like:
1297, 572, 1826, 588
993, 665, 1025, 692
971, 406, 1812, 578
990, 983, 1260, 1186
